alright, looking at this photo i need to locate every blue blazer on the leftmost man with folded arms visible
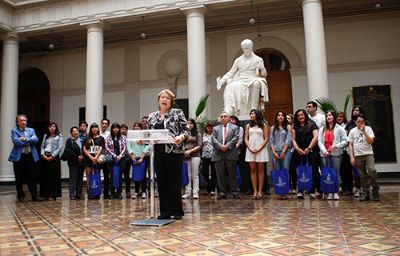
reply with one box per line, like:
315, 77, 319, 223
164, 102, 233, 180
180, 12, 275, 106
8, 127, 39, 162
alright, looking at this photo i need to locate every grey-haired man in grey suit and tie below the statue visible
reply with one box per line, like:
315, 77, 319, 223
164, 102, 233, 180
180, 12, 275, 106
212, 111, 239, 199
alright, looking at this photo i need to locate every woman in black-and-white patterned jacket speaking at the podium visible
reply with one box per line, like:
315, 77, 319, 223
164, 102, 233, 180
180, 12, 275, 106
148, 89, 189, 220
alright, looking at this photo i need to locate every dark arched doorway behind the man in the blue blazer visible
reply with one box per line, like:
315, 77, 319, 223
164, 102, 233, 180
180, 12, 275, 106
18, 68, 50, 147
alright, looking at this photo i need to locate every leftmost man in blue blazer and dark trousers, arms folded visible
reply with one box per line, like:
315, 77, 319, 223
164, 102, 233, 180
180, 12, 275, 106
8, 115, 41, 202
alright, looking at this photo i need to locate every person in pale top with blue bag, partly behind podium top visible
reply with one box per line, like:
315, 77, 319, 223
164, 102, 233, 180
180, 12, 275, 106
127, 122, 149, 199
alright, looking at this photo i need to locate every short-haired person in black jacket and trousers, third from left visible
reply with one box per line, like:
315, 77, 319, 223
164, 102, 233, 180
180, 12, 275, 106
62, 126, 83, 200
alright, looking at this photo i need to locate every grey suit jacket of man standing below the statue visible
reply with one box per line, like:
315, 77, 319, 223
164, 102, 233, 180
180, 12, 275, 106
212, 123, 239, 161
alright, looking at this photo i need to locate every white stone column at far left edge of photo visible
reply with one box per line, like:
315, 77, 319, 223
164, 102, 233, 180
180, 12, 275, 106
0, 33, 19, 181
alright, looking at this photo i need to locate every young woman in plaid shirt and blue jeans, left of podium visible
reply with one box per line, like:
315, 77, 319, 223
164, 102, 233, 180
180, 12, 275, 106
104, 123, 126, 199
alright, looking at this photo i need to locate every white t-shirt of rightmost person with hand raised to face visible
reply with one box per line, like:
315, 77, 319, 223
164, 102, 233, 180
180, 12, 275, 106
349, 126, 375, 156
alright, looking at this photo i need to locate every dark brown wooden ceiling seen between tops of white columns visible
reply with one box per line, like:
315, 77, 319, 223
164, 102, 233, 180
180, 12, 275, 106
7, 0, 400, 55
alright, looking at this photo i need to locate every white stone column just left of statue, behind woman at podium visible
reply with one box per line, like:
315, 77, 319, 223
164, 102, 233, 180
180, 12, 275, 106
182, 6, 207, 118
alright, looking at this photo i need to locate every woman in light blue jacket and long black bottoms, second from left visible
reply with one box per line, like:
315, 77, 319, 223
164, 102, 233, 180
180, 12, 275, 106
40, 122, 63, 200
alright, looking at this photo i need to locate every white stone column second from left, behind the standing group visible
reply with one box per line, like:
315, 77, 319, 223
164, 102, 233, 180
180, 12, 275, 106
86, 22, 104, 126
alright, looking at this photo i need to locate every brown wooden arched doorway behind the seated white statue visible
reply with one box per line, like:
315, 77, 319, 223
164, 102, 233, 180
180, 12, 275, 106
255, 48, 293, 125
